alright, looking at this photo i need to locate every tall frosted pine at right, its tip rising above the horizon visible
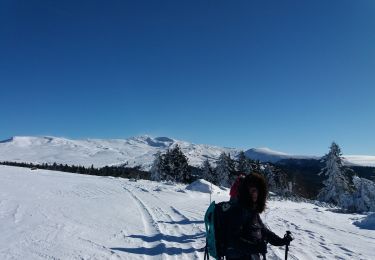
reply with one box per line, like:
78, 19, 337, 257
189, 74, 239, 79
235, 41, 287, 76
318, 142, 353, 208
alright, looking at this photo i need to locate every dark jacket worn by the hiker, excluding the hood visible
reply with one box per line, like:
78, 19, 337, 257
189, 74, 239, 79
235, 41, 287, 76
223, 202, 285, 259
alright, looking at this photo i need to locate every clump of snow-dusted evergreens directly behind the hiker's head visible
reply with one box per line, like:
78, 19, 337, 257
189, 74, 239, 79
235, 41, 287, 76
150, 145, 288, 192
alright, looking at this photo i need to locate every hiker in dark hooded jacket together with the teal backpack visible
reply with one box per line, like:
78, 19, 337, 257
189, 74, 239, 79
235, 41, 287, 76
205, 173, 293, 260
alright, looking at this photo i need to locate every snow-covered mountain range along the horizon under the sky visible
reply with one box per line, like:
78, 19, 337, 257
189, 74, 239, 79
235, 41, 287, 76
0, 135, 375, 170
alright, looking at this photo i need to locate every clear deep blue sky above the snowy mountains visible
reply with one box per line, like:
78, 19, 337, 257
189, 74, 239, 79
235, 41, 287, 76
0, 0, 375, 155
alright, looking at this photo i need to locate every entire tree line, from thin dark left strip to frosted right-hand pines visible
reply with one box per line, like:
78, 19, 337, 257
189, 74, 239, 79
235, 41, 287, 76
0, 142, 375, 212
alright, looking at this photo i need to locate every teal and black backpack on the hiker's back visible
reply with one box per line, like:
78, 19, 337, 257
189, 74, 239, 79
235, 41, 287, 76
204, 201, 231, 259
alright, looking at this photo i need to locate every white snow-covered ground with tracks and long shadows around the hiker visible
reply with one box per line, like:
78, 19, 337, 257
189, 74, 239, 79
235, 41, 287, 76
0, 166, 375, 259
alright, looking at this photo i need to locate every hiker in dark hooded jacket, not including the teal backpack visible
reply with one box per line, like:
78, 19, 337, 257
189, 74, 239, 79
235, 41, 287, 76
223, 173, 293, 260
